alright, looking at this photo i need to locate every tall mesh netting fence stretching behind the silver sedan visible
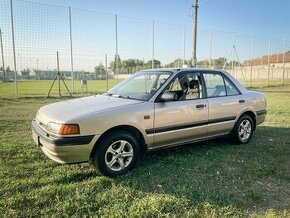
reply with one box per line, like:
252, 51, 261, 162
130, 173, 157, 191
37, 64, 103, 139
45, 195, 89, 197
0, 0, 290, 97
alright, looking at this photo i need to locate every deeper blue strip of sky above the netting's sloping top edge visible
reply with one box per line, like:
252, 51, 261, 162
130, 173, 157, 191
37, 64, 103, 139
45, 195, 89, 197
32, 0, 290, 39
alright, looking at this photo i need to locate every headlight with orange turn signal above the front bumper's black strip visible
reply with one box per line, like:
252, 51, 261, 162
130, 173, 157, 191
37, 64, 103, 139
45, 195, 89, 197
46, 123, 80, 135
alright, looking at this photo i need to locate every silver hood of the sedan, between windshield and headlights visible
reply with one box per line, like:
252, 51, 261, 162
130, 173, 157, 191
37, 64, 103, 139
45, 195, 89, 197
36, 95, 142, 125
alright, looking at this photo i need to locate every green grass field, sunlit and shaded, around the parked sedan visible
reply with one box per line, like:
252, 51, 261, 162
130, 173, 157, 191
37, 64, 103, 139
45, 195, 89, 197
0, 83, 290, 217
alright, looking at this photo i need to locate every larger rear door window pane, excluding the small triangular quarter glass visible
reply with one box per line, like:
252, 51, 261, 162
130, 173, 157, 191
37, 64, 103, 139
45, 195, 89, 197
203, 73, 227, 98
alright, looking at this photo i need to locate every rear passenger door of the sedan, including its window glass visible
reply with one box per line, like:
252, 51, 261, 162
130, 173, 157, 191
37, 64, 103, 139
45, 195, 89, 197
203, 72, 244, 136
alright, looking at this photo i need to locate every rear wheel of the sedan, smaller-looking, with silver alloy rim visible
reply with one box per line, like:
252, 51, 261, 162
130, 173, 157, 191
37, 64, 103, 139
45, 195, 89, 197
230, 115, 255, 144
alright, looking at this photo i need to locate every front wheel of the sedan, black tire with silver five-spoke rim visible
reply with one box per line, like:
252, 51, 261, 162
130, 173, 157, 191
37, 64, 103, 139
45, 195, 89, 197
93, 131, 139, 177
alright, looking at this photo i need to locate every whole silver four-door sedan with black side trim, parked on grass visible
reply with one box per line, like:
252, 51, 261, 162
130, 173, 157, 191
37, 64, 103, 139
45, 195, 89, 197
32, 69, 266, 176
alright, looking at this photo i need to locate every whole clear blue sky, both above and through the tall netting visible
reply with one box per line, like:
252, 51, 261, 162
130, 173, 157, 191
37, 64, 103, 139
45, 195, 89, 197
0, 0, 290, 70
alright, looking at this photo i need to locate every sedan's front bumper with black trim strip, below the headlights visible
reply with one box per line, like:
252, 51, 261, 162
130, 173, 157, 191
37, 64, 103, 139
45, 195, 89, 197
32, 120, 99, 164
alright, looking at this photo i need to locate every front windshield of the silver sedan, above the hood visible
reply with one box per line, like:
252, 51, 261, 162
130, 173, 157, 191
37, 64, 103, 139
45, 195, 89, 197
107, 71, 172, 101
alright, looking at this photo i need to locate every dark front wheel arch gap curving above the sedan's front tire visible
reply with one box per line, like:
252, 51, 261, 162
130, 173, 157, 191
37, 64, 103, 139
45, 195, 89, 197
90, 125, 147, 158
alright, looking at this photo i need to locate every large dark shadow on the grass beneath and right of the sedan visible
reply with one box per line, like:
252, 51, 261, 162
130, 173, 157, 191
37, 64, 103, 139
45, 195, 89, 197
115, 126, 290, 214
